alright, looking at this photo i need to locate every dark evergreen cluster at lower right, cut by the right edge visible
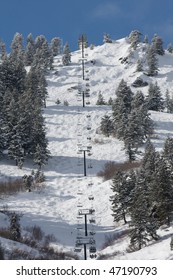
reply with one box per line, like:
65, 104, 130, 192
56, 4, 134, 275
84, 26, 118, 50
110, 138, 173, 250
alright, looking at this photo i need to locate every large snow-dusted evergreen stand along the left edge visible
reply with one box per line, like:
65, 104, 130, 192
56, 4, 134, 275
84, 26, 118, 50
0, 33, 61, 168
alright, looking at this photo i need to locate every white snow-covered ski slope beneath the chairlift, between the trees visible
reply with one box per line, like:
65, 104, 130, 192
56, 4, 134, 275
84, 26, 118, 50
0, 39, 173, 259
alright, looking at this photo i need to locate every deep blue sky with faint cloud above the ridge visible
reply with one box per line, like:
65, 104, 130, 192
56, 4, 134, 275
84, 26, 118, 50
0, 0, 173, 51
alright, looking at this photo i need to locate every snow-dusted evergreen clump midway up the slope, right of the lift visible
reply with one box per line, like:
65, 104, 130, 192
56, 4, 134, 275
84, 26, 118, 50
101, 80, 153, 161
